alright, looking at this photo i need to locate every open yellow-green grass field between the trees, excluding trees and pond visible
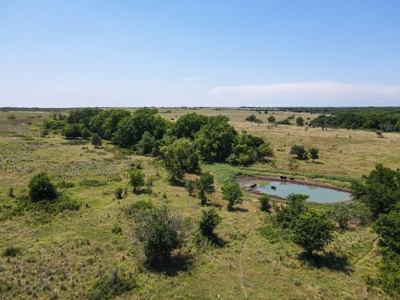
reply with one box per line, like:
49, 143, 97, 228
0, 108, 400, 299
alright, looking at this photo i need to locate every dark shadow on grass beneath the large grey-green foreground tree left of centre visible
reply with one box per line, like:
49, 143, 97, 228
145, 250, 194, 277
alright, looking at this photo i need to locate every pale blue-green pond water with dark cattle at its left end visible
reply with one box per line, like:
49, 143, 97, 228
255, 181, 350, 203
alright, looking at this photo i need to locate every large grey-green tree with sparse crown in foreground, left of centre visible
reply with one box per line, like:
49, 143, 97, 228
135, 206, 182, 267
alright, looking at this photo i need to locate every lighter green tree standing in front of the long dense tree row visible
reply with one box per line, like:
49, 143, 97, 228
160, 138, 200, 181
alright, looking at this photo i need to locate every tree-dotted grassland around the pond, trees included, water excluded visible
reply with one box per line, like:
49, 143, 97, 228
0, 108, 400, 299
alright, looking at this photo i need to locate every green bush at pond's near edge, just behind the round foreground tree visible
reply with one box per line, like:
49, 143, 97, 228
275, 194, 309, 228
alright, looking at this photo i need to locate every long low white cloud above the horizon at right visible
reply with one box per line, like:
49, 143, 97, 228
209, 82, 400, 106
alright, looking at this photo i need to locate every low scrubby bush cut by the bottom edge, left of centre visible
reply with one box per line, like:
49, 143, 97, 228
88, 269, 137, 300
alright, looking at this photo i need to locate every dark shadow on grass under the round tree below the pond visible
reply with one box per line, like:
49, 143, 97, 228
299, 251, 353, 275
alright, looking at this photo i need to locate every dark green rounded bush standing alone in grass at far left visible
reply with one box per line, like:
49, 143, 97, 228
28, 172, 58, 202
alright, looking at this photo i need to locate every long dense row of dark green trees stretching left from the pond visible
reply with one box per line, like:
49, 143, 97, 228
43, 107, 272, 165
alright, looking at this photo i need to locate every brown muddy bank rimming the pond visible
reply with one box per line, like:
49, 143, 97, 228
236, 175, 352, 203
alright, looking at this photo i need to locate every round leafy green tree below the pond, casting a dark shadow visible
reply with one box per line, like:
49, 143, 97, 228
293, 210, 335, 255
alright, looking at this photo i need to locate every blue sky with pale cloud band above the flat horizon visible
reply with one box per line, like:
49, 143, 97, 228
0, 0, 400, 107
